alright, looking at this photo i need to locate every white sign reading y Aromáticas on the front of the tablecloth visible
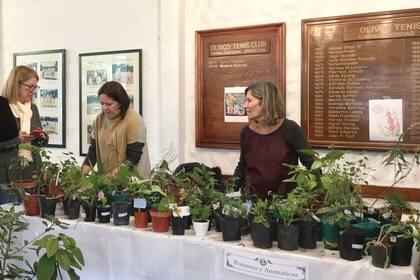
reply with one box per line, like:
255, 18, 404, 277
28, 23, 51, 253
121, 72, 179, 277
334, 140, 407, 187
225, 248, 309, 280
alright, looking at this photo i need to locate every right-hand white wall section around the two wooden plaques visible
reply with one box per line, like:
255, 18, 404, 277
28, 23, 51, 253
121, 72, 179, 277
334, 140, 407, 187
180, 0, 420, 189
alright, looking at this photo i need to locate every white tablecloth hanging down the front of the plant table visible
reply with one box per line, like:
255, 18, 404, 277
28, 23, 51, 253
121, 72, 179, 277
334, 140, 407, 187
11, 207, 418, 280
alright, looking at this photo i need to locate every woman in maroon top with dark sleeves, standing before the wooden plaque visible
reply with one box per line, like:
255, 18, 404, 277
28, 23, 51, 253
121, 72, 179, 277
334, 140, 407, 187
234, 82, 313, 198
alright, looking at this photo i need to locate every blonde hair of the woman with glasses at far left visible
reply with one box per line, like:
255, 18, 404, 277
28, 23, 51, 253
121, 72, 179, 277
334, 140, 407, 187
1, 65, 39, 104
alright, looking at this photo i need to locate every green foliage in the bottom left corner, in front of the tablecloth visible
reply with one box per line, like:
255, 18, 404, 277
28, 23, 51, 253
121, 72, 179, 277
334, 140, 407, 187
0, 207, 84, 280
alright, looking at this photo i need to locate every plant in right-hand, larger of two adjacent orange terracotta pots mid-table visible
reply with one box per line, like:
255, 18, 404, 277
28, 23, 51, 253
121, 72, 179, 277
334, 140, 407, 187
150, 195, 176, 232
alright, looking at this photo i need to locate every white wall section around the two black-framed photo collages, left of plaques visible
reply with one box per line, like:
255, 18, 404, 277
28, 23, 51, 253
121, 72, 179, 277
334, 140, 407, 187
0, 0, 179, 168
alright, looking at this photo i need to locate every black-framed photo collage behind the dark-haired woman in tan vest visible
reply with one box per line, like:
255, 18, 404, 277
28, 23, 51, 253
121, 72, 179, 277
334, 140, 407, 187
79, 49, 142, 155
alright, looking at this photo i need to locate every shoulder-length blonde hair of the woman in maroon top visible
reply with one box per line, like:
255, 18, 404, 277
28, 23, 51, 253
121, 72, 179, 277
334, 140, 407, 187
245, 82, 286, 125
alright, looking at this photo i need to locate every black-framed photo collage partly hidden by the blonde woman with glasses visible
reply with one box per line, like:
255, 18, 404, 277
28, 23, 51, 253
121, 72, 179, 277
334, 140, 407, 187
13, 49, 66, 148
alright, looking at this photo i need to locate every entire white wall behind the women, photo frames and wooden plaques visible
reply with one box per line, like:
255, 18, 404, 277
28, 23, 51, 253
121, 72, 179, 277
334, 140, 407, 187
0, 0, 420, 190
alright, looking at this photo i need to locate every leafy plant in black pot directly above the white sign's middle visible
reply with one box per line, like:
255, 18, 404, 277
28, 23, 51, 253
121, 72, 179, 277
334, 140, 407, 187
251, 199, 273, 249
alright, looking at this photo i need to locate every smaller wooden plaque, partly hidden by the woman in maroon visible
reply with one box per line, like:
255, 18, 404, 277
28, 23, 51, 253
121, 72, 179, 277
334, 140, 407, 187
196, 23, 285, 148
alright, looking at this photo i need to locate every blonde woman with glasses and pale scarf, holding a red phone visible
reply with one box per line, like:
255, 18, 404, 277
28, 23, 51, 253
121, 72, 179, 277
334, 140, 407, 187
0, 66, 48, 199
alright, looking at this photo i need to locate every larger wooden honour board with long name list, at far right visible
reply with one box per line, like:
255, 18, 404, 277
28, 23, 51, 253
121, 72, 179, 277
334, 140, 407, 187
301, 9, 420, 150
